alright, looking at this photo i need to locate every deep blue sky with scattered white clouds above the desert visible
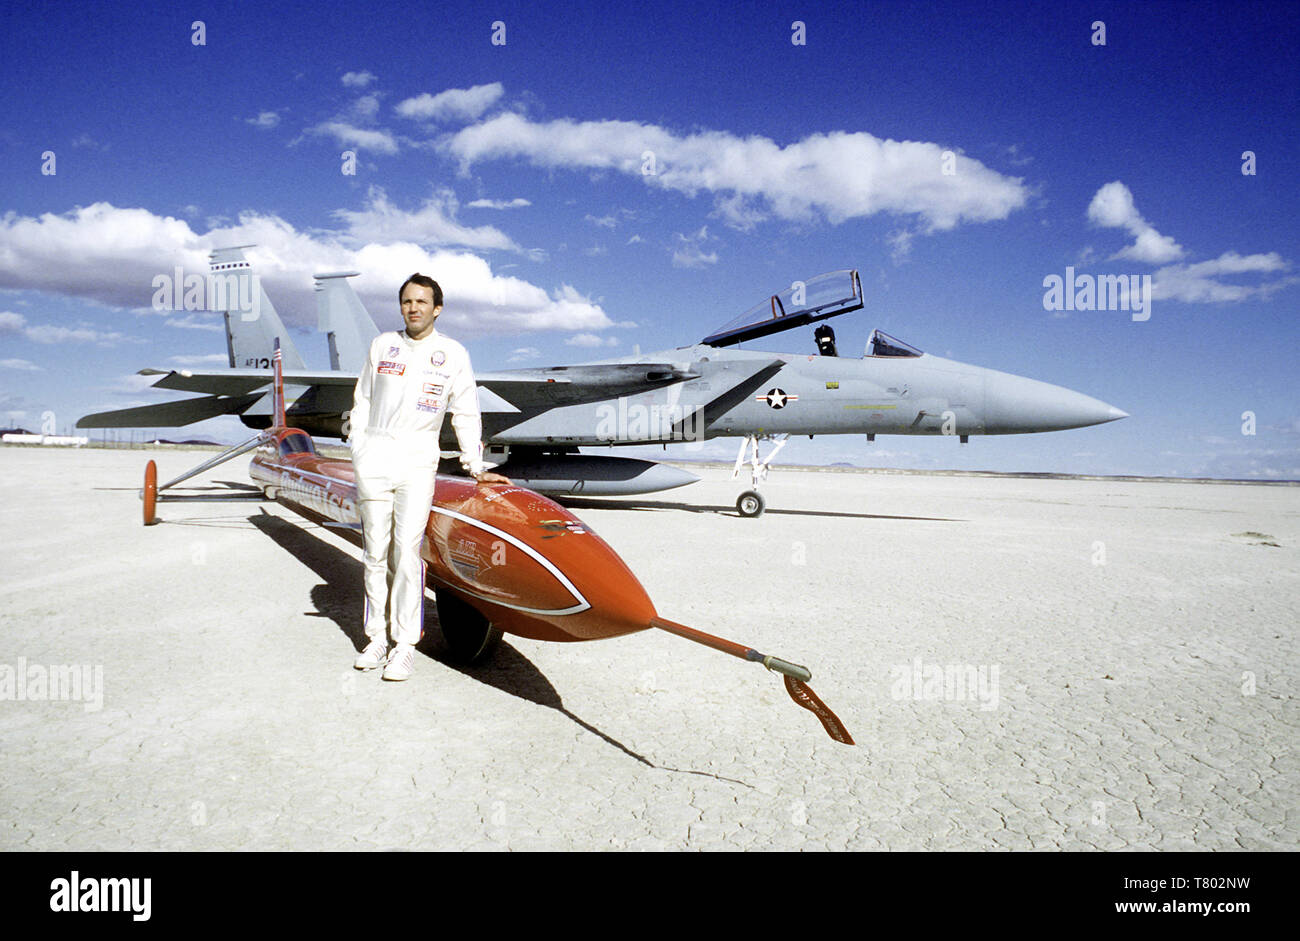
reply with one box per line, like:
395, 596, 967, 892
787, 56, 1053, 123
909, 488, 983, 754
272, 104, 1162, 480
0, 3, 1300, 478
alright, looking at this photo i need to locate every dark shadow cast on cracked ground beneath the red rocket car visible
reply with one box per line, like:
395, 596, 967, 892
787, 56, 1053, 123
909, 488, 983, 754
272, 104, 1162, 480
248, 511, 751, 786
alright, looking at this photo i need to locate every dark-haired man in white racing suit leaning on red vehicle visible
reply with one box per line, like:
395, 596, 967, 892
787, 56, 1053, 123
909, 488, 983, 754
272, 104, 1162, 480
348, 267, 510, 680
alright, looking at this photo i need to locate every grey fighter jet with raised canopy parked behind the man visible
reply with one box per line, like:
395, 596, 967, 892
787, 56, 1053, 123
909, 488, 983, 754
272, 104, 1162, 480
78, 250, 1127, 516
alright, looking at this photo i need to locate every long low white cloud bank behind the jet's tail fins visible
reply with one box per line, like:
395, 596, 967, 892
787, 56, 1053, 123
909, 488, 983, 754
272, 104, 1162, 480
0, 200, 612, 342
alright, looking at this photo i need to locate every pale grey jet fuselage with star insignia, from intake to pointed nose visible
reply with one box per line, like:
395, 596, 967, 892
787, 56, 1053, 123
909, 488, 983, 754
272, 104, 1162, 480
484, 344, 1126, 447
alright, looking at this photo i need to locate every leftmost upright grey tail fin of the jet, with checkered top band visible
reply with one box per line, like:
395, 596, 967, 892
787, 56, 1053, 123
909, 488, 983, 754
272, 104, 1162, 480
208, 246, 307, 369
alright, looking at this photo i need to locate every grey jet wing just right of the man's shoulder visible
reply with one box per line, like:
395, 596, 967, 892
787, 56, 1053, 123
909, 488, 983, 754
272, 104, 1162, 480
475, 363, 699, 411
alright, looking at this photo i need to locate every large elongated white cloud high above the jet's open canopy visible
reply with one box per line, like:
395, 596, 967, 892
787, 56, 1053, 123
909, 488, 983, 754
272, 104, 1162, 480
441, 113, 1028, 231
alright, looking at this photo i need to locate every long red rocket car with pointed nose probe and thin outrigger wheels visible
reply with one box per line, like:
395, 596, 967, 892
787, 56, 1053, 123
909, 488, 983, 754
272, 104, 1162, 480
142, 344, 854, 745
